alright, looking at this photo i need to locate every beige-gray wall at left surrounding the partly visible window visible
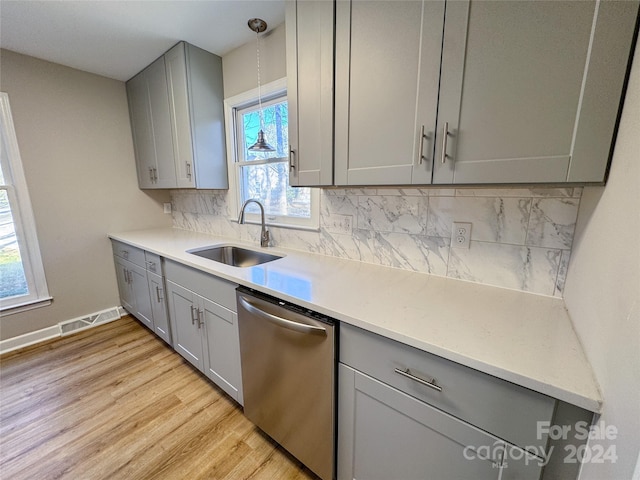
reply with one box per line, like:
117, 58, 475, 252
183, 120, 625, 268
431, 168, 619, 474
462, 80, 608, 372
0, 50, 171, 340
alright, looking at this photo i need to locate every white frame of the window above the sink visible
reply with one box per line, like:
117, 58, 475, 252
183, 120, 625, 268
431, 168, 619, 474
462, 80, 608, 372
224, 78, 320, 231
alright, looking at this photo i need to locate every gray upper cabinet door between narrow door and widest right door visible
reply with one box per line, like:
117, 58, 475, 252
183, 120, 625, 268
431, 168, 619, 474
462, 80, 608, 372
335, 1, 444, 185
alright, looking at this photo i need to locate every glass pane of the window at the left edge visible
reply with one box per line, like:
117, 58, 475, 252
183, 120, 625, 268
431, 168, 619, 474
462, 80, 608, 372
0, 190, 29, 298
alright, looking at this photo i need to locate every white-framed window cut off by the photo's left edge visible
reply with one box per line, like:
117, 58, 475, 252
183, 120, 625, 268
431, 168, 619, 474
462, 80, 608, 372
0, 93, 51, 313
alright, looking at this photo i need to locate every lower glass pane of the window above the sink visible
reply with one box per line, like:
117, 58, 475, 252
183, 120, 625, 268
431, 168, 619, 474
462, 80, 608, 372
240, 162, 311, 218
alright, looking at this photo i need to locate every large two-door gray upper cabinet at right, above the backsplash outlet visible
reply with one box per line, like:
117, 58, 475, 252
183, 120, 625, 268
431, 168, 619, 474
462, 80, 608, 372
324, 0, 639, 186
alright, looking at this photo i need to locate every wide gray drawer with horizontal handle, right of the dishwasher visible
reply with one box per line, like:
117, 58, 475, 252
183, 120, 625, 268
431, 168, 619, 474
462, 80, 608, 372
340, 324, 556, 453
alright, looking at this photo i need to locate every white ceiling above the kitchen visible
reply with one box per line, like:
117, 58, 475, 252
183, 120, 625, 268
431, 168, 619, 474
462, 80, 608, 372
0, 0, 284, 80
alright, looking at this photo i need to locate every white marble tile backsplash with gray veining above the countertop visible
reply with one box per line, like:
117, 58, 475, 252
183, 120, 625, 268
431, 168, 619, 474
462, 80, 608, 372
171, 188, 582, 297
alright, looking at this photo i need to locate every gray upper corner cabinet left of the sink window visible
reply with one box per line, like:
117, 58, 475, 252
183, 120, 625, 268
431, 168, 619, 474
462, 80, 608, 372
127, 42, 229, 189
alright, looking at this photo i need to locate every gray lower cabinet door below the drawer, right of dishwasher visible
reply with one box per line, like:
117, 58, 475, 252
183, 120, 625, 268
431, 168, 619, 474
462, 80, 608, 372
338, 364, 504, 480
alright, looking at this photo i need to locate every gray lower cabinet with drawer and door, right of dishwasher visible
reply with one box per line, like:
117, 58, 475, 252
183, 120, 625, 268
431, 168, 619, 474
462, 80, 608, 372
337, 324, 593, 480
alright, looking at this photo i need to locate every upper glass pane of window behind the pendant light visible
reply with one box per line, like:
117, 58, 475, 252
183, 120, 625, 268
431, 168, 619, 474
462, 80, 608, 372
240, 101, 289, 162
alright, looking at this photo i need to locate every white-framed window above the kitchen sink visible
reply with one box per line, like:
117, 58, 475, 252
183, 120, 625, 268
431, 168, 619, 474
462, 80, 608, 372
226, 80, 318, 228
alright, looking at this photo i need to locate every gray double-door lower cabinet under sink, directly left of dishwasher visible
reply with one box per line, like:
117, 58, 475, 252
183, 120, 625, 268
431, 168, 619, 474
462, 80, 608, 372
165, 260, 243, 404
